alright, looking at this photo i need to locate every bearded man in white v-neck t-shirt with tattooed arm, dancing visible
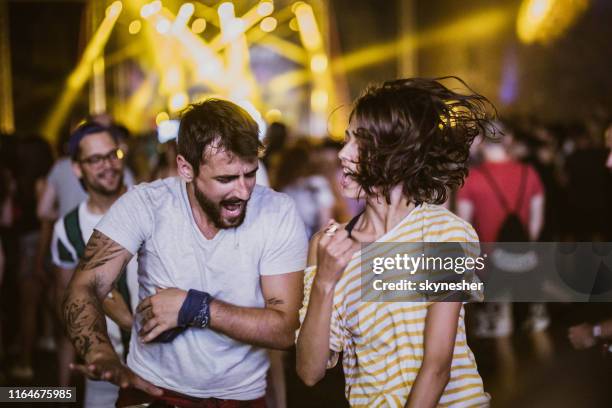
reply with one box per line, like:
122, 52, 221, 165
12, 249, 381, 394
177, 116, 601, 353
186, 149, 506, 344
63, 99, 307, 407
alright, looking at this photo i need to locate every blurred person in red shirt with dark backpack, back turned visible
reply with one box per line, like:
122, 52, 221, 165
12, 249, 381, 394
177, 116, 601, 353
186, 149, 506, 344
457, 123, 550, 396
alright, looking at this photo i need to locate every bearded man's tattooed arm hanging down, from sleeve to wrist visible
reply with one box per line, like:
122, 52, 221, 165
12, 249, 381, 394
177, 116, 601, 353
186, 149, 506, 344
62, 230, 132, 362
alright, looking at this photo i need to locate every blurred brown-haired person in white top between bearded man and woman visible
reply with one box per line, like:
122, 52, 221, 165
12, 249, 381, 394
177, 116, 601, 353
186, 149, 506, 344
274, 141, 334, 239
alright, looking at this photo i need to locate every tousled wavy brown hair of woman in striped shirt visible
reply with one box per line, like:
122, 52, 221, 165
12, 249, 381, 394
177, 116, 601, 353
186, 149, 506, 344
349, 77, 495, 204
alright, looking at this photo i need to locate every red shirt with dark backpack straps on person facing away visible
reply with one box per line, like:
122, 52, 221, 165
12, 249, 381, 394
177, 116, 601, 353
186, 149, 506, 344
457, 161, 543, 242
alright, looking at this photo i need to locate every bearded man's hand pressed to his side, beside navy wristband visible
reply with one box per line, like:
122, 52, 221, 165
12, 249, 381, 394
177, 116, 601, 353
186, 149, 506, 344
136, 288, 187, 343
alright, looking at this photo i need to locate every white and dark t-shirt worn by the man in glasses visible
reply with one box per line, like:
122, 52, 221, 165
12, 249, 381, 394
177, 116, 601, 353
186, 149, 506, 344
51, 201, 138, 358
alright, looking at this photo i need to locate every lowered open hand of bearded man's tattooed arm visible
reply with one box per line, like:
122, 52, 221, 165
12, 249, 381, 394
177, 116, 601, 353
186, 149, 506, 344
70, 355, 163, 397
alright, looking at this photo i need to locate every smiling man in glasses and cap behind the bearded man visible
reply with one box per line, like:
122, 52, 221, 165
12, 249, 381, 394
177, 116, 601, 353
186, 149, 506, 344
51, 122, 138, 408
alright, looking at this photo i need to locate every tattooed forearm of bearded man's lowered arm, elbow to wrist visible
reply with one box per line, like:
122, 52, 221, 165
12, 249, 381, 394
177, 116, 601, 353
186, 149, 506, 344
62, 285, 115, 361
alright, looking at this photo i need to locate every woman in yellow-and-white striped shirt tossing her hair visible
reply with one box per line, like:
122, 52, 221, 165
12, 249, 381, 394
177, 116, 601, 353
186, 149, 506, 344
297, 79, 489, 407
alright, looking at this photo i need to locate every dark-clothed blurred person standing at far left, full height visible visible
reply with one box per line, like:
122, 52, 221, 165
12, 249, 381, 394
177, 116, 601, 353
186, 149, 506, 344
11, 135, 53, 381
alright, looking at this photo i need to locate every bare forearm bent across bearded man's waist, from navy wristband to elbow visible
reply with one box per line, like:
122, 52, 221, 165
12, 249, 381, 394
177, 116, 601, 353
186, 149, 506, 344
210, 299, 299, 349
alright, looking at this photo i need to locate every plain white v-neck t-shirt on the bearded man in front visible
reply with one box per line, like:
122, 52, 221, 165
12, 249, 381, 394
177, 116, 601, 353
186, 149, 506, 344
96, 177, 308, 400
